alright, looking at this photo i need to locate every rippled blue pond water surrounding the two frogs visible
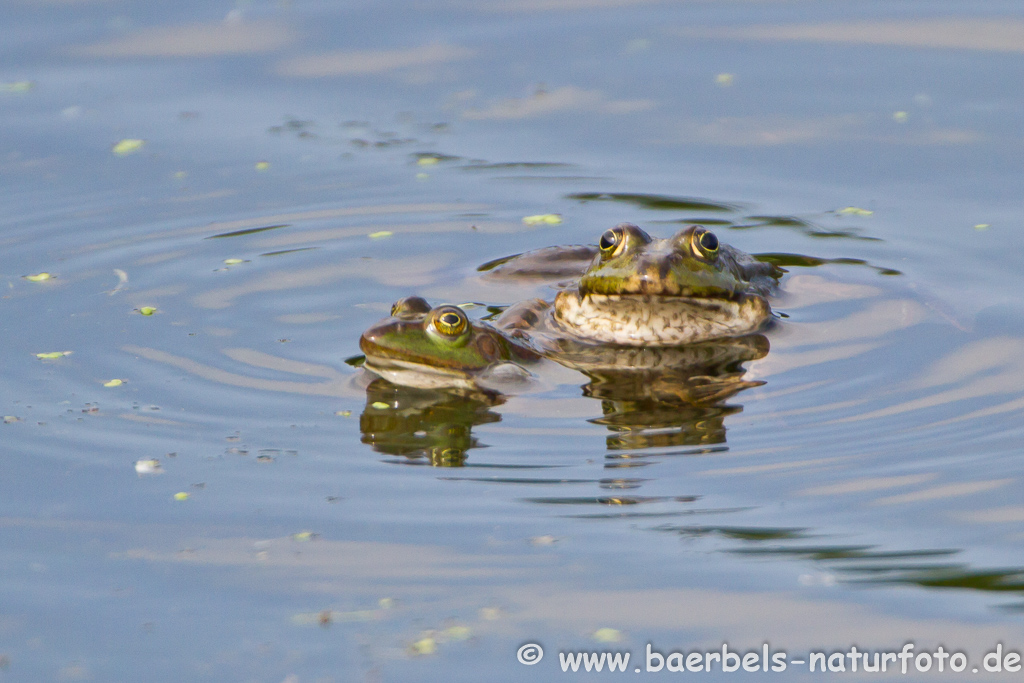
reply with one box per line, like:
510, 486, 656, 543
0, 0, 1024, 682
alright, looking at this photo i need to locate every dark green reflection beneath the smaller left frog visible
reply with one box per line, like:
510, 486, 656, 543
359, 379, 505, 467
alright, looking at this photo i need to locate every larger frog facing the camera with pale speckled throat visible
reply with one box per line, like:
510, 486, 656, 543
483, 223, 782, 346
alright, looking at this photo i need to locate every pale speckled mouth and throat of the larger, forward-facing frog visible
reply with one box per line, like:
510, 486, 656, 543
555, 290, 771, 346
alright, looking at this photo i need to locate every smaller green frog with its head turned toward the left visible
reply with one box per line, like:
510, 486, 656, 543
359, 297, 540, 389
